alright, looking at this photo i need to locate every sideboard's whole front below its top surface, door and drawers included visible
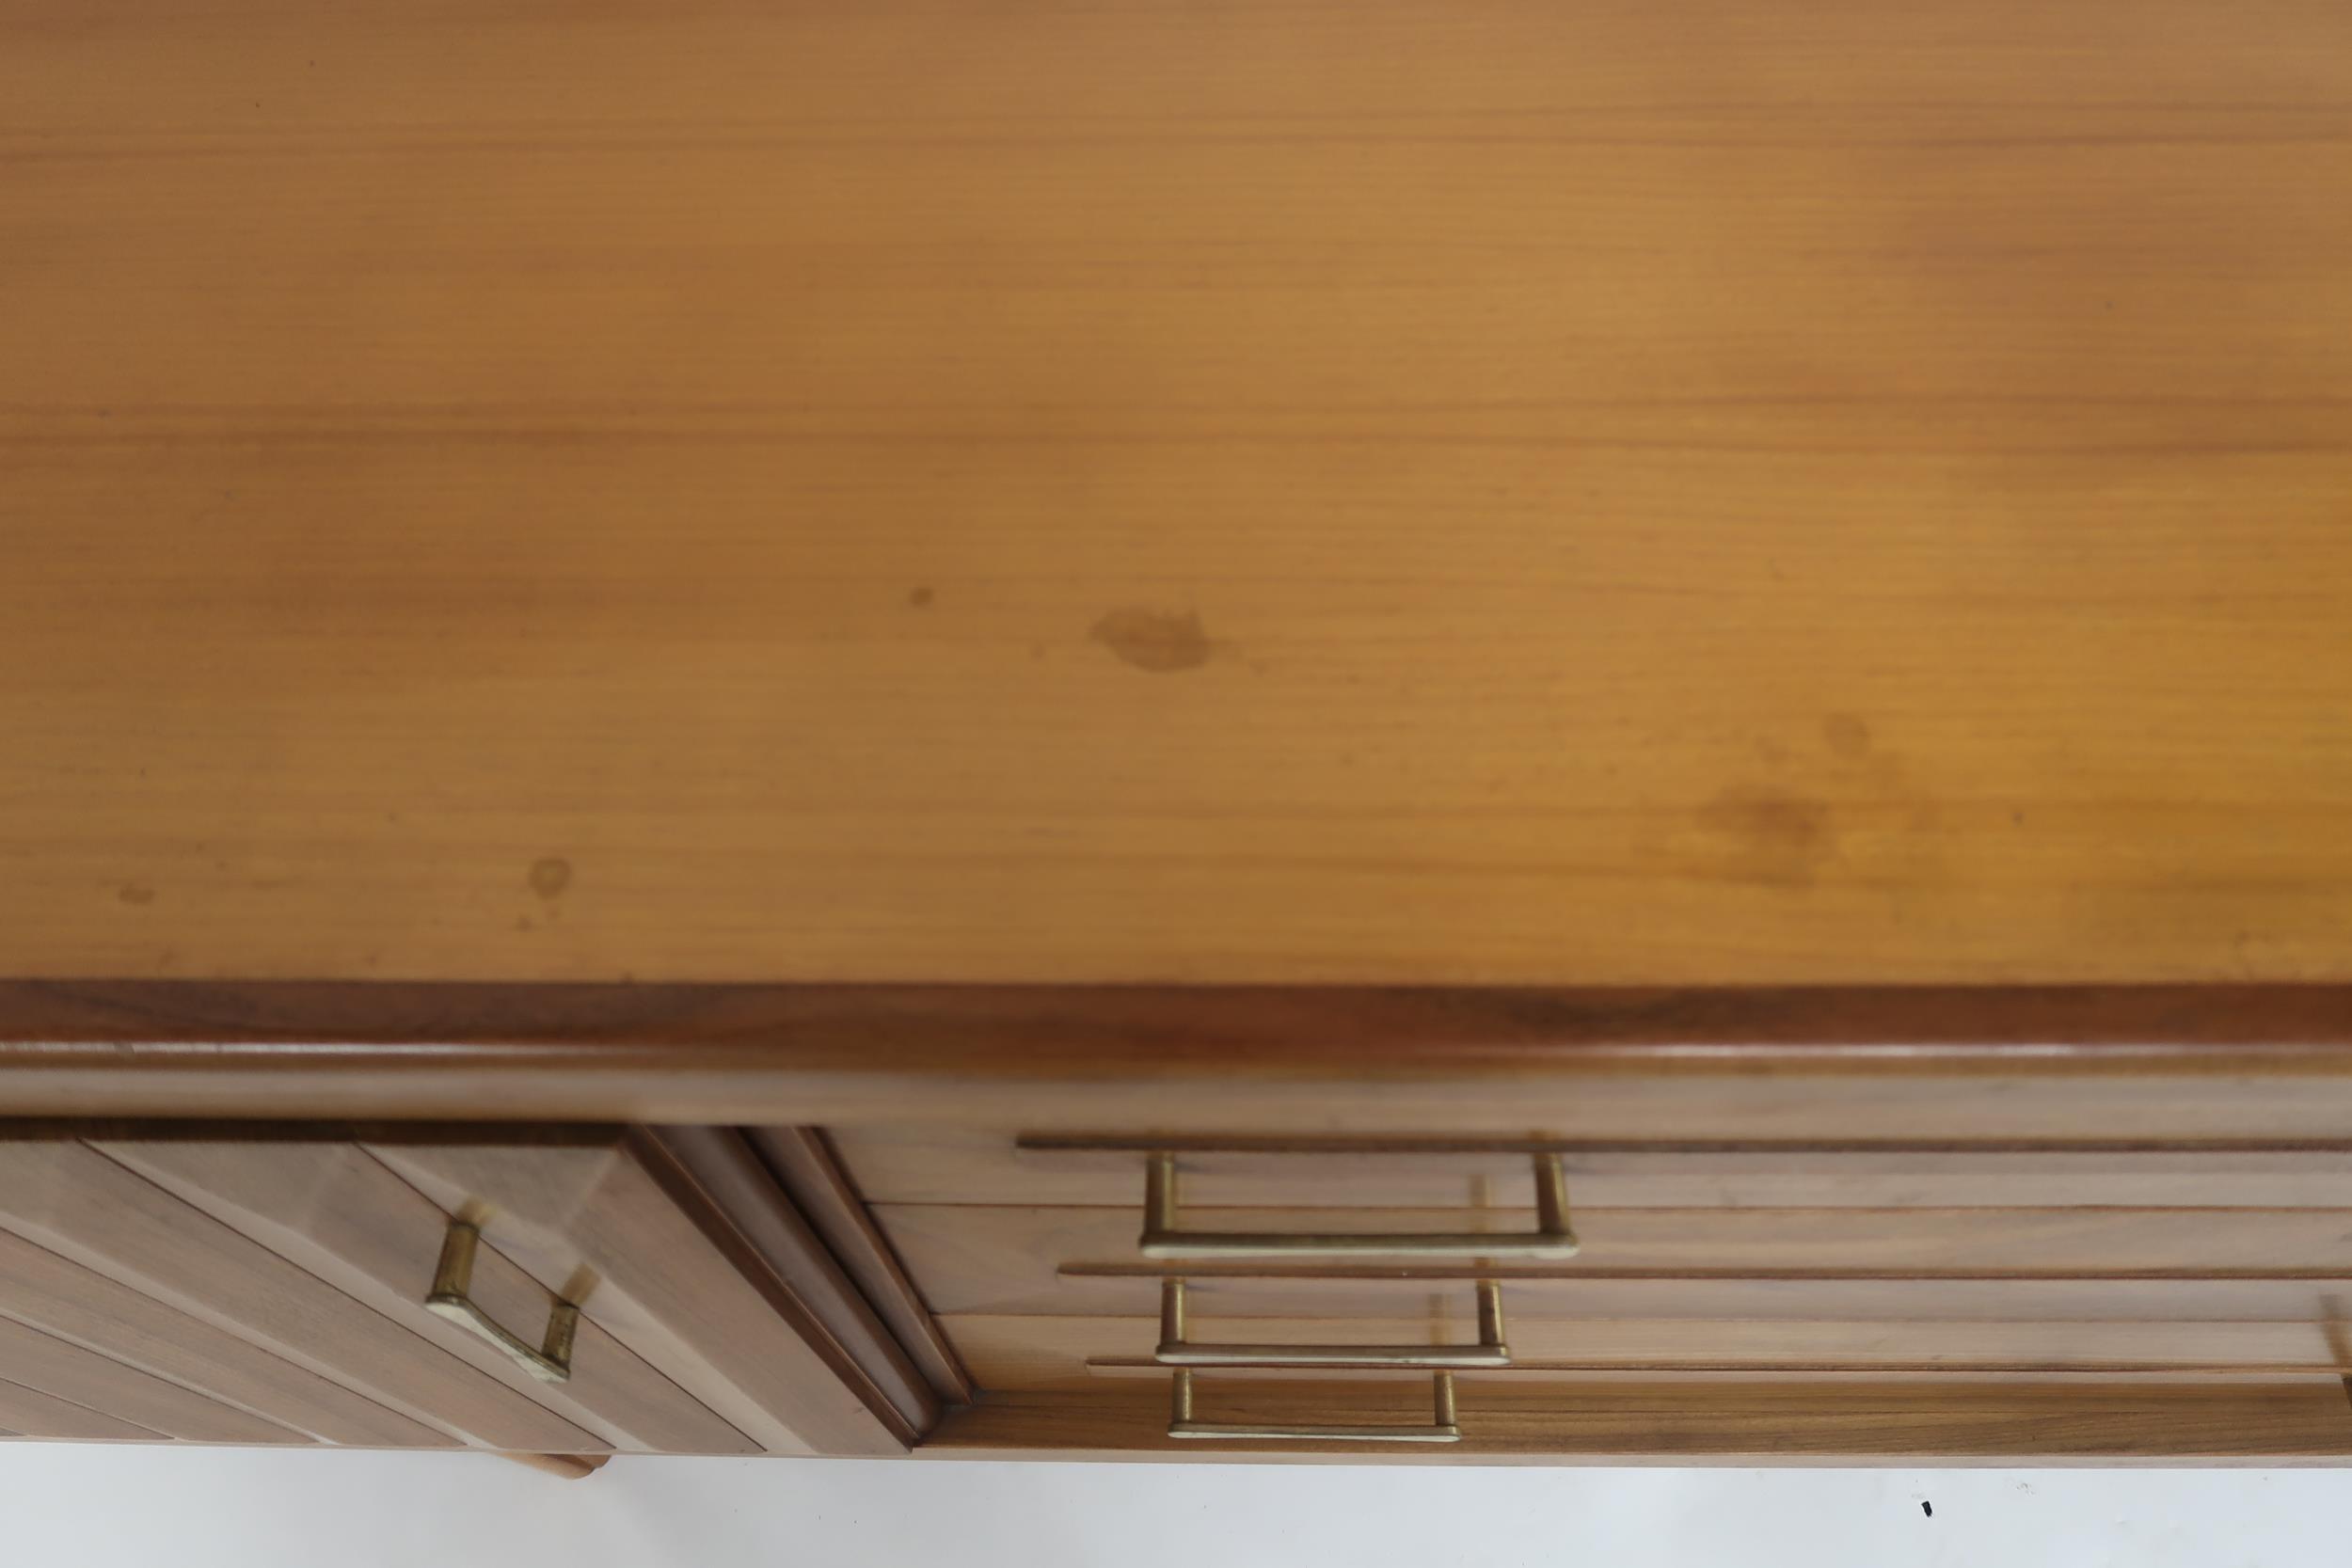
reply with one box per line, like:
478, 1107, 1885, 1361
0, 983, 2352, 1467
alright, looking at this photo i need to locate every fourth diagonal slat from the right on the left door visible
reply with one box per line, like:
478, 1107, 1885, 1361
0, 1232, 459, 1449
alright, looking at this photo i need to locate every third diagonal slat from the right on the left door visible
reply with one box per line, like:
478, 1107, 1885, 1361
0, 1140, 605, 1453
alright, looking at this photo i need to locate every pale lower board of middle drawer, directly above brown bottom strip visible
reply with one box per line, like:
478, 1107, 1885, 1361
944, 1316, 2352, 1392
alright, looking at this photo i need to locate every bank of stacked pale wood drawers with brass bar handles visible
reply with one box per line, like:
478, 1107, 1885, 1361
833, 1129, 2352, 1453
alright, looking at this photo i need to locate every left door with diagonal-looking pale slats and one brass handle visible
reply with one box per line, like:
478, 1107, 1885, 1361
0, 1131, 920, 1455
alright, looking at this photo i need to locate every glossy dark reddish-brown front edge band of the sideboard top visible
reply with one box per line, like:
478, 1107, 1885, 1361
13, 980, 2352, 1077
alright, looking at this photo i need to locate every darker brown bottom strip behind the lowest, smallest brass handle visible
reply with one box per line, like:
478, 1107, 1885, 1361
922, 1378, 2352, 1465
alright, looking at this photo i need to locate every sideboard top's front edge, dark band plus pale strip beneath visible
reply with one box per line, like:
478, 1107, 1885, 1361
0, 980, 2352, 1135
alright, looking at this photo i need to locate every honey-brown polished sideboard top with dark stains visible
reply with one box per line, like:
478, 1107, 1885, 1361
0, 0, 2352, 983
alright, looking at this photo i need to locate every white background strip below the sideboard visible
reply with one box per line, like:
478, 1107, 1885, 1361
0, 1444, 2352, 1568
